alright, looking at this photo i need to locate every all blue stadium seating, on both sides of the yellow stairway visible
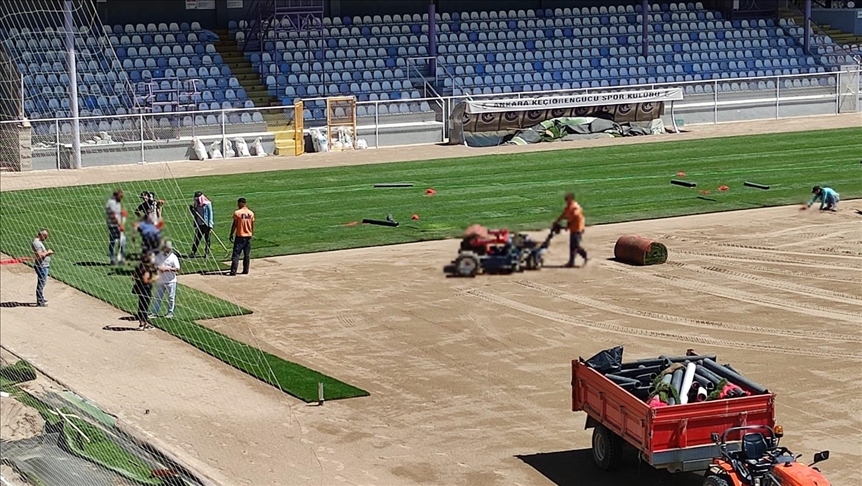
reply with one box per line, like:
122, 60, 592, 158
4, 3, 862, 132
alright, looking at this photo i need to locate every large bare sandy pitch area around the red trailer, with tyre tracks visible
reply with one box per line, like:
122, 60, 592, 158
0, 201, 862, 486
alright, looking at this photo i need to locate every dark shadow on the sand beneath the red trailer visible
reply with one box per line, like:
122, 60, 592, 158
516, 448, 703, 486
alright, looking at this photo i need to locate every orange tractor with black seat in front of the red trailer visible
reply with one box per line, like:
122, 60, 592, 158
703, 425, 829, 486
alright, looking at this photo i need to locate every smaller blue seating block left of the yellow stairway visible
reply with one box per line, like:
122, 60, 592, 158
4, 23, 262, 131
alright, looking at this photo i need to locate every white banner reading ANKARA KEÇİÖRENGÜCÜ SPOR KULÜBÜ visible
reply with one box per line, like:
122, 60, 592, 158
467, 88, 683, 113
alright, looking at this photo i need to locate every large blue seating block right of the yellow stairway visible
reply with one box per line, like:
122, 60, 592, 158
235, 3, 855, 119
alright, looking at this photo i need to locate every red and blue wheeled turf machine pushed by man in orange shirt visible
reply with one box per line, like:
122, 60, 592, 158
443, 225, 560, 277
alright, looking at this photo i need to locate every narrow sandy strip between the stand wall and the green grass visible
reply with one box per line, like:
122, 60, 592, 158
0, 113, 862, 191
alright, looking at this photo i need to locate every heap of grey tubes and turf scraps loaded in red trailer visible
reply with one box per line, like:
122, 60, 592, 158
581, 346, 769, 408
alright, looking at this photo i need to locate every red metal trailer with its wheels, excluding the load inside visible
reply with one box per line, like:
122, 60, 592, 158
572, 360, 775, 472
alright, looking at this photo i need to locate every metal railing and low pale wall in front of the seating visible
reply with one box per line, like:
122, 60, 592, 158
0, 71, 862, 168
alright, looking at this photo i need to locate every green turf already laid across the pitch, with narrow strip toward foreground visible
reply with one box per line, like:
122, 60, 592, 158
0, 128, 862, 400
